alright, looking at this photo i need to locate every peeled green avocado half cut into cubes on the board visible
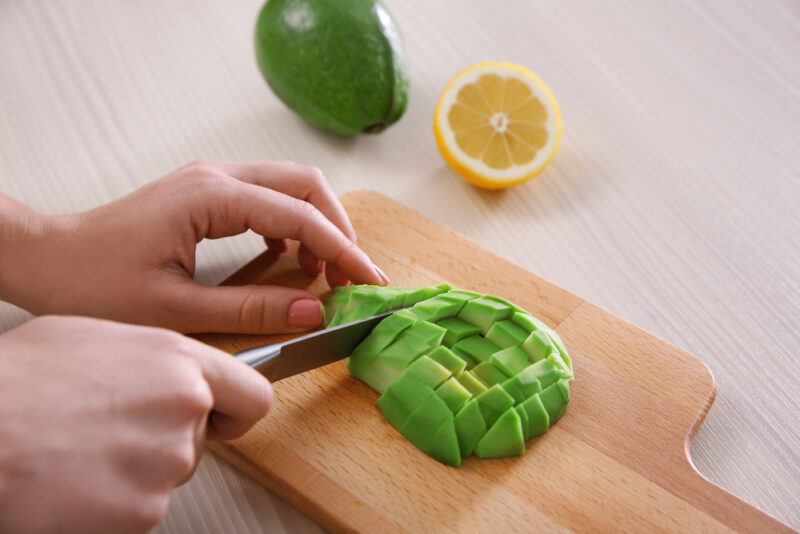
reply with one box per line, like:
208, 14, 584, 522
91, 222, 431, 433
324, 284, 573, 466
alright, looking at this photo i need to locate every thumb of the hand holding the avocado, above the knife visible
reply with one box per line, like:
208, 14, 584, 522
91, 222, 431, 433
167, 282, 323, 334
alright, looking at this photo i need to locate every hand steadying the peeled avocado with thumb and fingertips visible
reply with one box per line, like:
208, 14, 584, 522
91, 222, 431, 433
0, 162, 388, 333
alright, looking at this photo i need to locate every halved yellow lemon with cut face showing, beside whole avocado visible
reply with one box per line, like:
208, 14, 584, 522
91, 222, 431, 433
433, 61, 564, 189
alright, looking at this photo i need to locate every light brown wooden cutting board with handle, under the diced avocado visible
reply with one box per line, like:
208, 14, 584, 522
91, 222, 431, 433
199, 191, 790, 532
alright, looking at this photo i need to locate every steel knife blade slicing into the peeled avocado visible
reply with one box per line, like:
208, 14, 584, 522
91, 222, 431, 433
234, 310, 395, 382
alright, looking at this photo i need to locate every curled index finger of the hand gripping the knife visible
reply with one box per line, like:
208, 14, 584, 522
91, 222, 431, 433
180, 342, 273, 439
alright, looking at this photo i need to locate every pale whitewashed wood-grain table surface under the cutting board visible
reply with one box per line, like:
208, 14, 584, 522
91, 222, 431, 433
0, 0, 800, 533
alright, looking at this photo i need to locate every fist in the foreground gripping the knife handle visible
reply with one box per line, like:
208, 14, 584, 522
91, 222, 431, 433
0, 317, 272, 533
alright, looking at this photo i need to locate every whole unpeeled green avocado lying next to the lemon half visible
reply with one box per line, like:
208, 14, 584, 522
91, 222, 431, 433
256, 0, 408, 136
